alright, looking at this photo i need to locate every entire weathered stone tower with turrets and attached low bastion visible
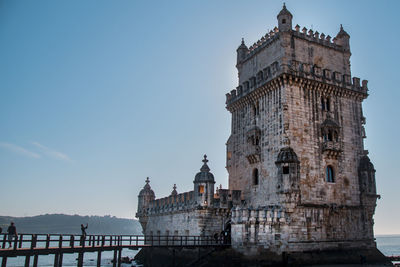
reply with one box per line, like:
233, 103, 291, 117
136, 2, 379, 262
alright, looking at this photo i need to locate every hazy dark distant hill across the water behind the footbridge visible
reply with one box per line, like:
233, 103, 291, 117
0, 214, 142, 235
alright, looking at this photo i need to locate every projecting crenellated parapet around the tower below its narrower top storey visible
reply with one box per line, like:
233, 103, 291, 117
226, 60, 368, 106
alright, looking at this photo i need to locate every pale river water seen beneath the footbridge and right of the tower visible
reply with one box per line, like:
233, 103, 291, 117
1, 235, 400, 267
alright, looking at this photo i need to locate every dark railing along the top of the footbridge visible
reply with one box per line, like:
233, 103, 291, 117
0, 233, 228, 250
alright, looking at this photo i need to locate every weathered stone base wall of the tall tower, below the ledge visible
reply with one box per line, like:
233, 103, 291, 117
231, 206, 376, 254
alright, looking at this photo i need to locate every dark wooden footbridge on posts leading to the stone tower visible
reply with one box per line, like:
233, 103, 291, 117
0, 234, 230, 267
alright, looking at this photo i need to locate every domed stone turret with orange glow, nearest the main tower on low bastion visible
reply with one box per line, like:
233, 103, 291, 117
193, 155, 215, 207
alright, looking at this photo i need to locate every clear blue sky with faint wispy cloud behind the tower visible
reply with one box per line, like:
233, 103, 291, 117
0, 0, 400, 234
